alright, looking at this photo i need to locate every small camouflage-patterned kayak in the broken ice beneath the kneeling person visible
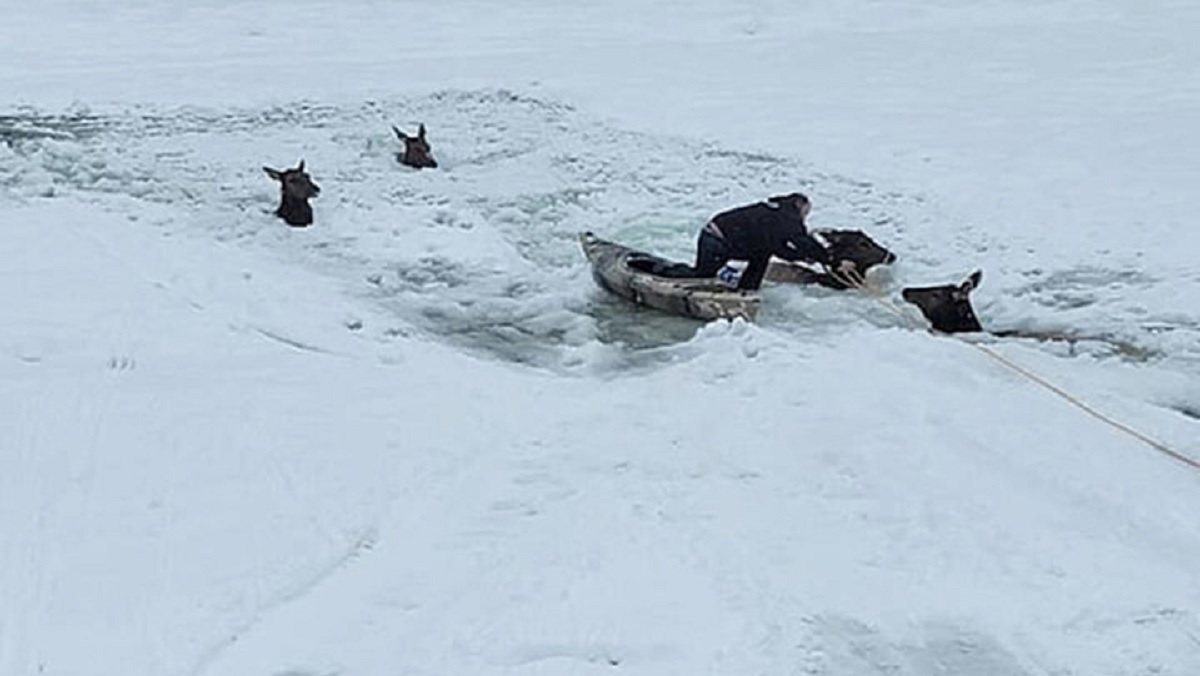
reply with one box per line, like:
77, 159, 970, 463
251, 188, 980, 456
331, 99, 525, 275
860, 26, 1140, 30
580, 232, 761, 321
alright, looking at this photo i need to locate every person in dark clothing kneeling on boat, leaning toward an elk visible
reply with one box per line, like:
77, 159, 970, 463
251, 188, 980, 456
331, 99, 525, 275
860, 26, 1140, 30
691, 192, 832, 291
